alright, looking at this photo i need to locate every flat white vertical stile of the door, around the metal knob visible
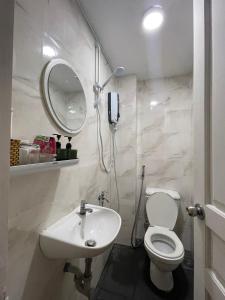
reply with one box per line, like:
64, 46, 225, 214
193, 0, 211, 300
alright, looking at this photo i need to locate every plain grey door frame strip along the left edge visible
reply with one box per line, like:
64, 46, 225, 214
0, 0, 14, 300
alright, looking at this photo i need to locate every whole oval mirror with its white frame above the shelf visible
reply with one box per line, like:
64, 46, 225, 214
43, 59, 87, 135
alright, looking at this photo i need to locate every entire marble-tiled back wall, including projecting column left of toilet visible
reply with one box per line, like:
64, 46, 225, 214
111, 75, 193, 250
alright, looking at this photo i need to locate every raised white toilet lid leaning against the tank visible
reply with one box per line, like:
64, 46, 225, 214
146, 192, 178, 230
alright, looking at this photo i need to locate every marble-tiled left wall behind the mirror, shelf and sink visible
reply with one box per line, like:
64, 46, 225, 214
8, 0, 114, 300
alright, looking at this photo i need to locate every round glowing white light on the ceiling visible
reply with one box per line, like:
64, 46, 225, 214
142, 5, 164, 31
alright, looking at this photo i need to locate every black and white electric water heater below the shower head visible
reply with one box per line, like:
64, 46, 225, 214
108, 92, 120, 124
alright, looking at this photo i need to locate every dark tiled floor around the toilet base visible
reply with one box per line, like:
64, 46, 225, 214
91, 244, 193, 300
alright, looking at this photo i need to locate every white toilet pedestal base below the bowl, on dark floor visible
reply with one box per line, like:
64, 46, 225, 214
150, 262, 174, 292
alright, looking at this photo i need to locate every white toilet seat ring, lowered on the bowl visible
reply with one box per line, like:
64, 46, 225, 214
144, 226, 184, 263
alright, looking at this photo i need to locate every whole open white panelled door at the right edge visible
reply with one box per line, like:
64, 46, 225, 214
194, 0, 225, 300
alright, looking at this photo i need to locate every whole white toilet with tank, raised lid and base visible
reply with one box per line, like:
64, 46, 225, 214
144, 188, 184, 292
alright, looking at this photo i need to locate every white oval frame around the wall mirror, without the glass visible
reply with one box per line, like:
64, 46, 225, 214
42, 58, 87, 135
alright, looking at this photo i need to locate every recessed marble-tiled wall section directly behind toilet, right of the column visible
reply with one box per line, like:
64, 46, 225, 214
137, 75, 193, 250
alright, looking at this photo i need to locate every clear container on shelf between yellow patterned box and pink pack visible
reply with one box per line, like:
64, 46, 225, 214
20, 142, 40, 165
